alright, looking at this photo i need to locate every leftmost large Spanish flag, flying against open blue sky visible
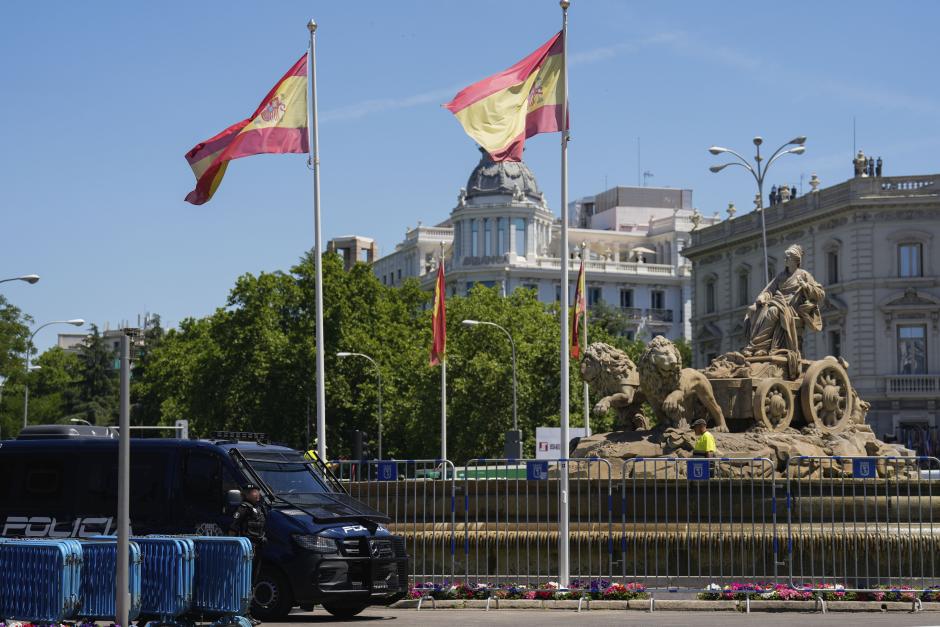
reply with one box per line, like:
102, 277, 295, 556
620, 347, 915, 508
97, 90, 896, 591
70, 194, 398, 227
186, 53, 310, 205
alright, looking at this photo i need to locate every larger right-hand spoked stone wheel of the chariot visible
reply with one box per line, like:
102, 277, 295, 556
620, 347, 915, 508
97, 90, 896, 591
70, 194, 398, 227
800, 358, 855, 433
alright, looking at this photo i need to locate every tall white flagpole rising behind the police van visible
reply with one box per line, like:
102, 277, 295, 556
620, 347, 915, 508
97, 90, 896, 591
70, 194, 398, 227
307, 20, 327, 463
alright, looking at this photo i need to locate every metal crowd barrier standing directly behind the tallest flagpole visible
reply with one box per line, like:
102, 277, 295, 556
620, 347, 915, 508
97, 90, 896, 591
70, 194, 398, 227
458, 458, 613, 587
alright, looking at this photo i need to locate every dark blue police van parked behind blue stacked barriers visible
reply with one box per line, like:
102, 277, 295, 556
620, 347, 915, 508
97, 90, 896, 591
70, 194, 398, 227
0, 425, 408, 620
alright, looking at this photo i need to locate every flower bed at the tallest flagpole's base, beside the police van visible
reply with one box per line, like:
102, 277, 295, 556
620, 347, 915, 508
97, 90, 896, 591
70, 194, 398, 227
408, 579, 648, 601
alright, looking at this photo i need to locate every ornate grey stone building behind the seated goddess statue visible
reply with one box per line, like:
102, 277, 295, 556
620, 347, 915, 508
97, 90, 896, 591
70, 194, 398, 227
683, 166, 940, 446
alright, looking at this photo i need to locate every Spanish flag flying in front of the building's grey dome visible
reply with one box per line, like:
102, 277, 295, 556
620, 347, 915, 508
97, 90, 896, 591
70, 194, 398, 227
444, 32, 564, 161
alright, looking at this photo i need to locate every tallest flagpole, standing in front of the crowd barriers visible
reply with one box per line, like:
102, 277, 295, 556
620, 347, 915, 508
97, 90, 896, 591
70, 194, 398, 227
558, 0, 571, 588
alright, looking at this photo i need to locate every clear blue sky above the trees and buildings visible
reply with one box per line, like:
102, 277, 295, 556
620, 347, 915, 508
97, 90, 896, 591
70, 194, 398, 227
0, 0, 940, 349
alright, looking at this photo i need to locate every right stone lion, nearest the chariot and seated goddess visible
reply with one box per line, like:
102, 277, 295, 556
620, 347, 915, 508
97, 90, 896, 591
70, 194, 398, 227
638, 335, 728, 432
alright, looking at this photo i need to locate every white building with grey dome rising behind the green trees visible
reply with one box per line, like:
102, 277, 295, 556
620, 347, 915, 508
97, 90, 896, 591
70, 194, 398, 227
373, 154, 716, 339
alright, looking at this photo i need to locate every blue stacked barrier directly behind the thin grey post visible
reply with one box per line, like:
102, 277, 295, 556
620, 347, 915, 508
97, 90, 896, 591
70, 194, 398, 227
77, 539, 141, 620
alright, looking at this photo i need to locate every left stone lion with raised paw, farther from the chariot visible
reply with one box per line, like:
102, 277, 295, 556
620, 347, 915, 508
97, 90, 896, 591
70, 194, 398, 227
581, 342, 649, 431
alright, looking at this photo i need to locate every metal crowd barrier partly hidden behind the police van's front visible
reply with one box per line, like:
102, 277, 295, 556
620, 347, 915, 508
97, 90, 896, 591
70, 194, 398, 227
332, 459, 457, 584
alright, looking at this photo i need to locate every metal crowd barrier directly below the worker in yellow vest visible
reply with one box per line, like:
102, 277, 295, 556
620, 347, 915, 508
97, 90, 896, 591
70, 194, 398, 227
620, 458, 783, 591
